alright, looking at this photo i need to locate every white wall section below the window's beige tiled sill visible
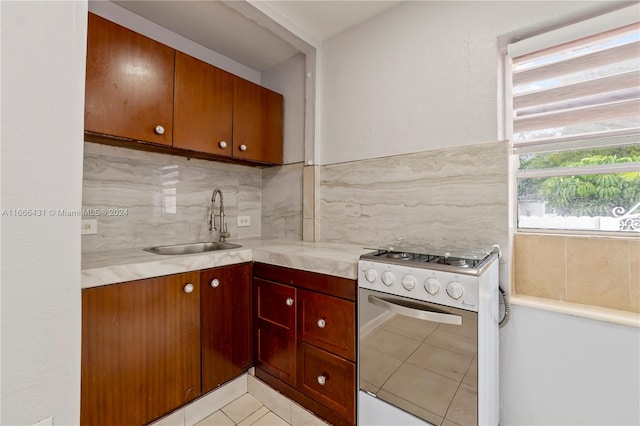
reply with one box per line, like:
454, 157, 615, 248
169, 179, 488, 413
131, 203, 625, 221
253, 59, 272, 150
500, 306, 640, 426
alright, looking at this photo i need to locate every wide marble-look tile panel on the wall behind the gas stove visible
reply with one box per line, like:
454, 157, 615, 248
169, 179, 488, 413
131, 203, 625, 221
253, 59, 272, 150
316, 142, 508, 251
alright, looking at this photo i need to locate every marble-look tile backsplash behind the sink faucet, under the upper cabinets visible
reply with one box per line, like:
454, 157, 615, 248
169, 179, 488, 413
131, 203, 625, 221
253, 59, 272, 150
82, 143, 262, 252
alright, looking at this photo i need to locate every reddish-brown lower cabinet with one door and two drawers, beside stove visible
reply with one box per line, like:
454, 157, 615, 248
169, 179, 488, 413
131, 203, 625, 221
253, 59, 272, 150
254, 263, 357, 425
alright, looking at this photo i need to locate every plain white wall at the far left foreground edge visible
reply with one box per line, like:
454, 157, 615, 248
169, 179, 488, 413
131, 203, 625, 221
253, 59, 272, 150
0, 1, 87, 425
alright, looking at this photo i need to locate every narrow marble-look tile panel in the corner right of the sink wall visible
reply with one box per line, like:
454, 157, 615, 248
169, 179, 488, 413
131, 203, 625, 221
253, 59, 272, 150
261, 163, 304, 241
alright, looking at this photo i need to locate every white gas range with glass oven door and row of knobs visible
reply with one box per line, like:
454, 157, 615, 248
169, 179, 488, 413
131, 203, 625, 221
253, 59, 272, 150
358, 242, 499, 426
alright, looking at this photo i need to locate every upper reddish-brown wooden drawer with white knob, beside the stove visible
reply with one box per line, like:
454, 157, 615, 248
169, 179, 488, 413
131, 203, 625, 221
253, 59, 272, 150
298, 290, 355, 361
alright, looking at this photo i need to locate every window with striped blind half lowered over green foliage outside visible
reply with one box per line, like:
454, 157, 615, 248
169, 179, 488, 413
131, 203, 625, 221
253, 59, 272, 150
505, 5, 640, 234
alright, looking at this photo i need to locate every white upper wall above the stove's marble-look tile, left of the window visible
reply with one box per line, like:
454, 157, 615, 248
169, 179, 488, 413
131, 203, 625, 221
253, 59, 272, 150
316, 1, 610, 164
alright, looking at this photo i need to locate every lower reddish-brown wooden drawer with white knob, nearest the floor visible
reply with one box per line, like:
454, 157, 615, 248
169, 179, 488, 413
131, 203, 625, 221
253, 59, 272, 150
298, 342, 356, 421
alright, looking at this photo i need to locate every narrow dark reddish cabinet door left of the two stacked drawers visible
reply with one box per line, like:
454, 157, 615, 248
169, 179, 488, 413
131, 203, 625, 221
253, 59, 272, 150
253, 278, 297, 386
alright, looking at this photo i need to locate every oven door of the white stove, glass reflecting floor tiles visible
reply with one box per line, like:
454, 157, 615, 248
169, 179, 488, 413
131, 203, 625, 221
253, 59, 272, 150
358, 288, 478, 426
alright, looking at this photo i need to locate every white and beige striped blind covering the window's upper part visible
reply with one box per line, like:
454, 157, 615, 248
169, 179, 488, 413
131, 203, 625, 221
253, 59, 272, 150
509, 13, 640, 152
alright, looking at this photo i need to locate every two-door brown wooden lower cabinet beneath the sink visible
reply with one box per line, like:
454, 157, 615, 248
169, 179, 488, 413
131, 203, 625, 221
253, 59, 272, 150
80, 263, 253, 426
